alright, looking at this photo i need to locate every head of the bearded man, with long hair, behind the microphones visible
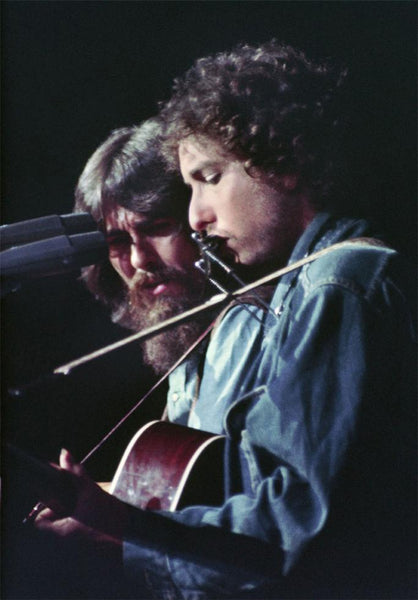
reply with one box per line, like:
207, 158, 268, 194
75, 119, 212, 374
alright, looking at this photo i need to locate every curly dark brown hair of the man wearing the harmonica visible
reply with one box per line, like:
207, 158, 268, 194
160, 40, 346, 207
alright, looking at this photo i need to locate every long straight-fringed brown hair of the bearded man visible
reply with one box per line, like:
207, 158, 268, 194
74, 119, 189, 327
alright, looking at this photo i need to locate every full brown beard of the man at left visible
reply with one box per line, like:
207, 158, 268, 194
128, 269, 213, 375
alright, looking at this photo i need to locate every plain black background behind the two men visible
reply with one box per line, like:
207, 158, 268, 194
1, 1, 416, 596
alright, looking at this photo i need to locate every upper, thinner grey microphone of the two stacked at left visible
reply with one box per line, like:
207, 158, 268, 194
0, 213, 97, 250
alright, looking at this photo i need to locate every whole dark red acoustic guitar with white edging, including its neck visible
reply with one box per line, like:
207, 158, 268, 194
7, 421, 225, 514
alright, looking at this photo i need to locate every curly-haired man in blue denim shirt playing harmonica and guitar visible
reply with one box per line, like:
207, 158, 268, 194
30, 42, 416, 599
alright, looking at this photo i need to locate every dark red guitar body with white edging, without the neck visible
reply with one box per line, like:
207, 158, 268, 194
109, 421, 225, 511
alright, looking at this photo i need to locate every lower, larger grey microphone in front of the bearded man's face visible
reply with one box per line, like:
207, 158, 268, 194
0, 231, 108, 287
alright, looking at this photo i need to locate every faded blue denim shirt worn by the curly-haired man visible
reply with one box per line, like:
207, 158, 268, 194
124, 214, 416, 600
